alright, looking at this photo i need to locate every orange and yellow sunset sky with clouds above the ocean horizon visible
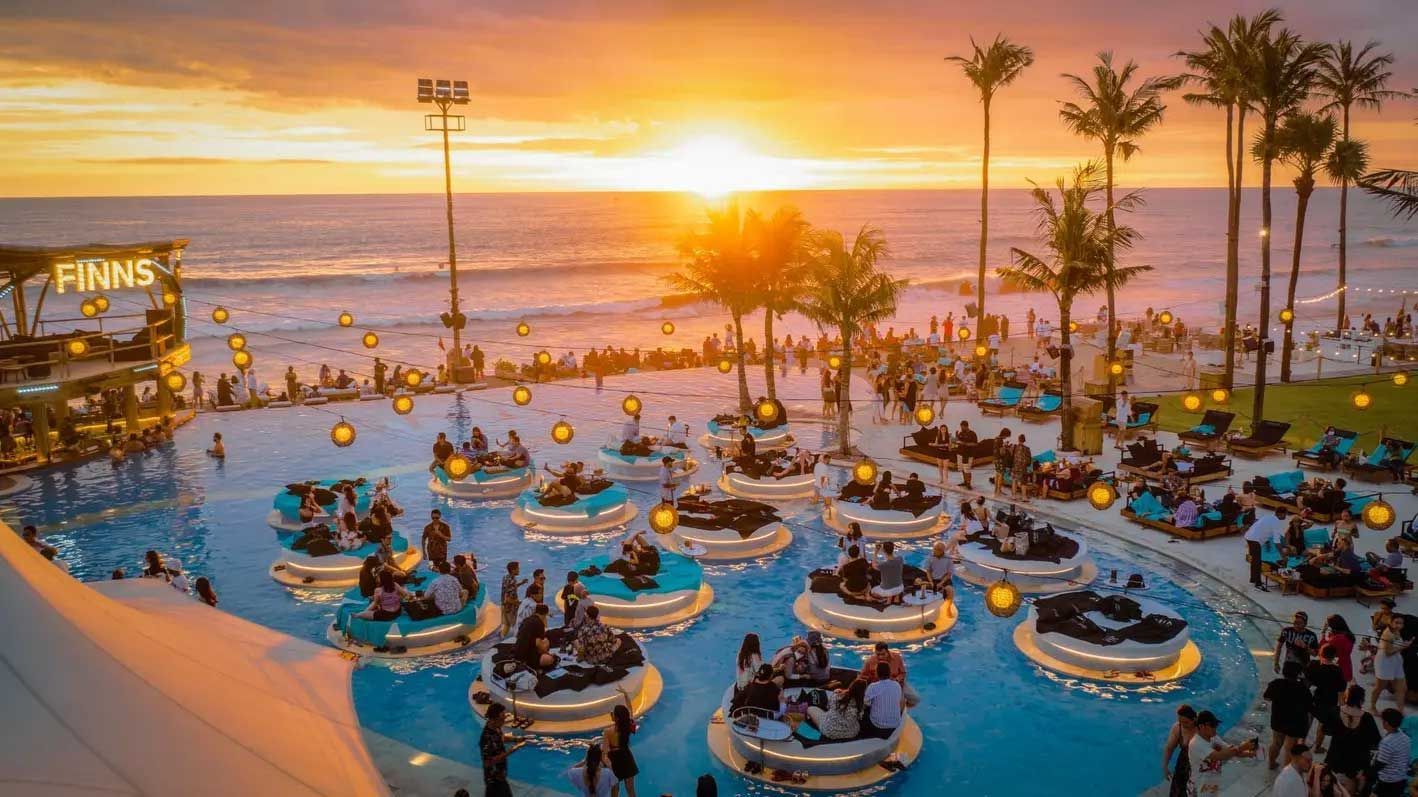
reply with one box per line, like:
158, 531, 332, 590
0, 0, 1418, 196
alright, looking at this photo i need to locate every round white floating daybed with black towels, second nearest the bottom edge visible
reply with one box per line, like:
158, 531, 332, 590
468, 648, 665, 735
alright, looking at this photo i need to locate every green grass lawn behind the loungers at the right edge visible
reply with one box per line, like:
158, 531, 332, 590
1137, 374, 1418, 452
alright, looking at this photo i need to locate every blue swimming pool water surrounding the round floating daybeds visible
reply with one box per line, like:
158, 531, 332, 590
7, 373, 1256, 796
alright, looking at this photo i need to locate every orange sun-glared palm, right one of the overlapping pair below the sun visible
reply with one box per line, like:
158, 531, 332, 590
752, 206, 808, 399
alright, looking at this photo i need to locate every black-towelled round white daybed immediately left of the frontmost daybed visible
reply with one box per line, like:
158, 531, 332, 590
468, 628, 665, 735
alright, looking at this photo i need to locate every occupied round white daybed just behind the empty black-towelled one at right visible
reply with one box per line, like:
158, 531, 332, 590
960, 532, 1098, 593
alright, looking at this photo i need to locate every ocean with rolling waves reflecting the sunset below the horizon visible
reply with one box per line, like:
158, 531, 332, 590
0, 191, 1418, 373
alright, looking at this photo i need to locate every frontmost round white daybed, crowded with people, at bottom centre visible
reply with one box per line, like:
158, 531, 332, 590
709, 667, 922, 793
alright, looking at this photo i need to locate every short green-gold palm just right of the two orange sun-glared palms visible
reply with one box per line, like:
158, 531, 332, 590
797, 225, 906, 454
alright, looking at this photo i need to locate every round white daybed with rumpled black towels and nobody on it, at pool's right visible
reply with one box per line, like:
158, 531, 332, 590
1014, 596, 1201, 684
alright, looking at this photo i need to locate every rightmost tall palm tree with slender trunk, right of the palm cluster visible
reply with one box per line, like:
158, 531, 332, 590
1314, 41, 1404, 329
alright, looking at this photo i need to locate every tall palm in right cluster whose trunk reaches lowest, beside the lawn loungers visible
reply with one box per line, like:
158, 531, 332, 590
1251, 30, 1324, 420
